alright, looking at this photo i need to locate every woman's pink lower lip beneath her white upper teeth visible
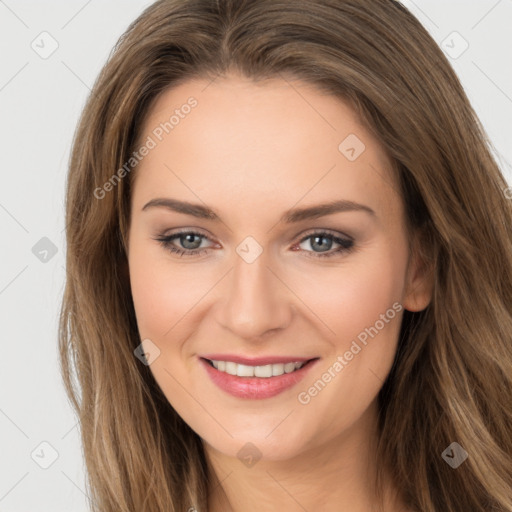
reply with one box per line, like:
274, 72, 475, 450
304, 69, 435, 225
199, 358, 318, 400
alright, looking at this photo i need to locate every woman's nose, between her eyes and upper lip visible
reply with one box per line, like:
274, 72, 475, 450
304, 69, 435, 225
218, 252, 293, 341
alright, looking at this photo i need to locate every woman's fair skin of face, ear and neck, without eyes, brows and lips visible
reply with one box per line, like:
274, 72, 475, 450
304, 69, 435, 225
128, 75, 431, 512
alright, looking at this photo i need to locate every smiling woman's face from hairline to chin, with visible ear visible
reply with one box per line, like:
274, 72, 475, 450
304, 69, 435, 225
129, 75, 430, 460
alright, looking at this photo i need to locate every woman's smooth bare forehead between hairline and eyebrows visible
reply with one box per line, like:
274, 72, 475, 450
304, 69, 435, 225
130, 76, 397, 219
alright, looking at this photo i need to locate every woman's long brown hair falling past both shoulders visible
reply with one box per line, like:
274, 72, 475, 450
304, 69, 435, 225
59, 0, 512, 512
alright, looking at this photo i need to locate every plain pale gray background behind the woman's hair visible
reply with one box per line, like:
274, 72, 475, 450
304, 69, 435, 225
0, 0, 512, 512
